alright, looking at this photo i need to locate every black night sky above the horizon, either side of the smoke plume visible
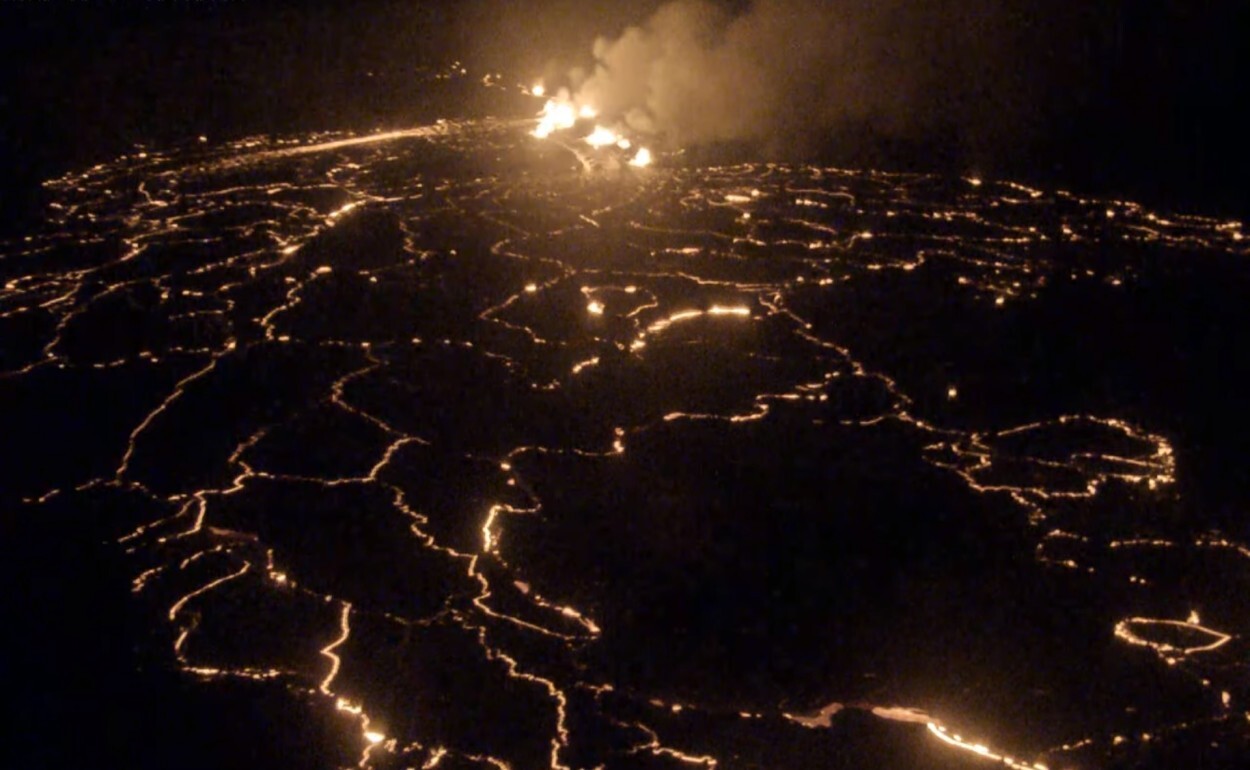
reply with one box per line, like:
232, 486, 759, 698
0, 0, 1250, 220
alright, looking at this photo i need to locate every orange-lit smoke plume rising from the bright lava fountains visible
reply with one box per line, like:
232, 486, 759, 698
570, 0, 1026, 159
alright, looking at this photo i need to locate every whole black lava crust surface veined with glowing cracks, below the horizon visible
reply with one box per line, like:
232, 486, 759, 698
0, 108, 1250, 770
